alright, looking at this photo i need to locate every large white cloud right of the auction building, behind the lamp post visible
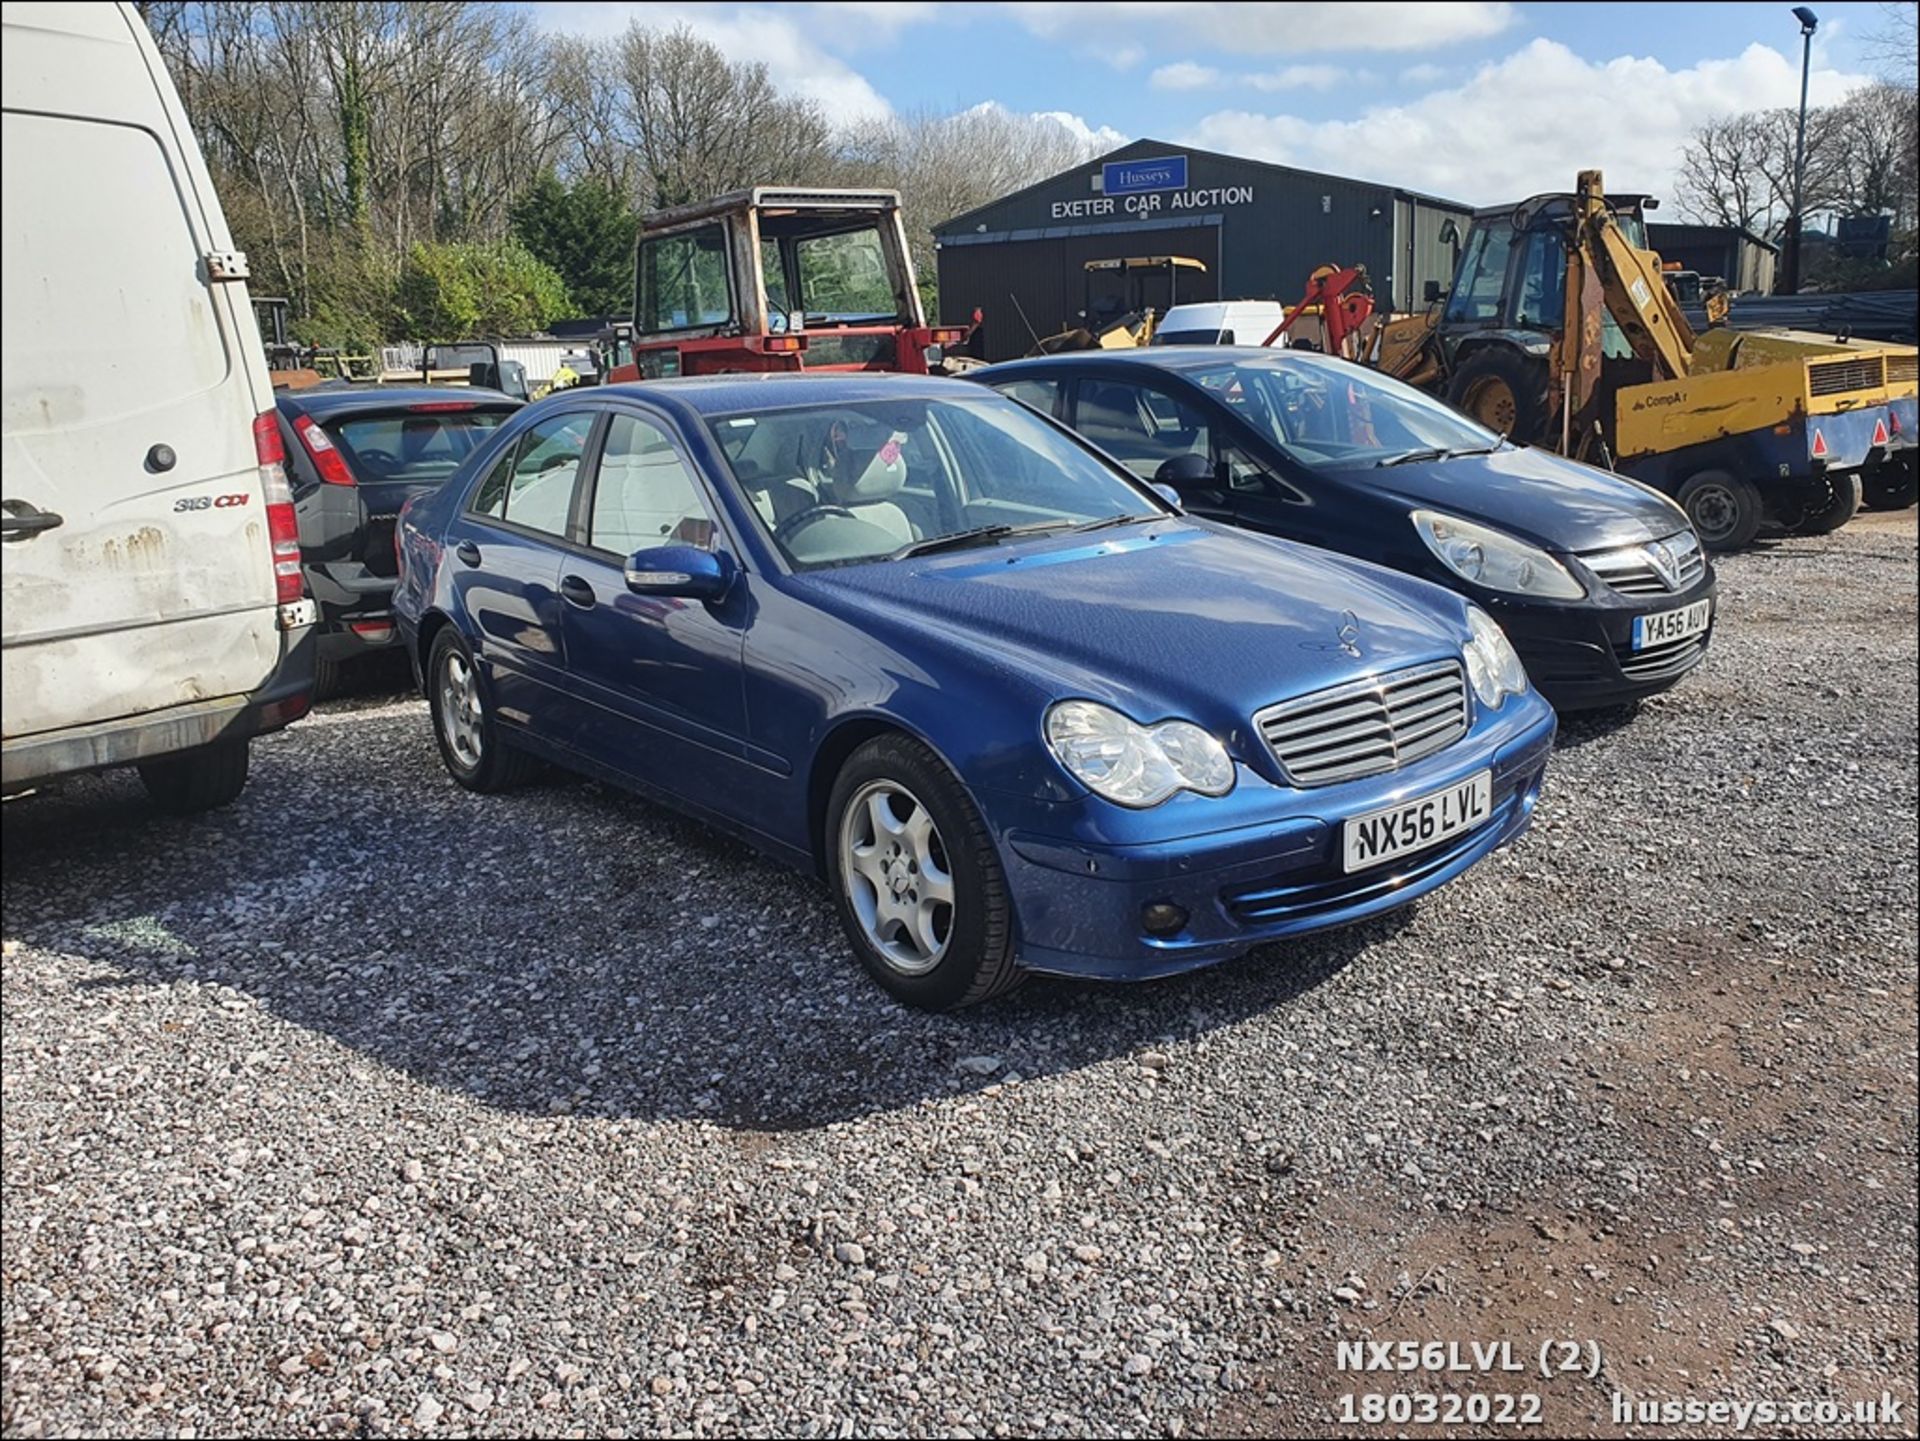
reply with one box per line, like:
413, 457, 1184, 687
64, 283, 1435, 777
1185, 40, 1868, 205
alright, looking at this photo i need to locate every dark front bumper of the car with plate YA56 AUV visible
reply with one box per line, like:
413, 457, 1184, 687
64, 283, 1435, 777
1482, 568, 1720, 710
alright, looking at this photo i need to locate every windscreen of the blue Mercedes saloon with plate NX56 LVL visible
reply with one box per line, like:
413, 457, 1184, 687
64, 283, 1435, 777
708, 401, 1167, 570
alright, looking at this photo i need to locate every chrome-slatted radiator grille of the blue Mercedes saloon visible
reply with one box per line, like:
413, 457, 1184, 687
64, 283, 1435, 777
1254, 660, 1467, 787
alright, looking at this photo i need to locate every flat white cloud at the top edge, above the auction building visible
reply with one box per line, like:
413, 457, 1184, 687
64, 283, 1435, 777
1008, 0, 1515, 56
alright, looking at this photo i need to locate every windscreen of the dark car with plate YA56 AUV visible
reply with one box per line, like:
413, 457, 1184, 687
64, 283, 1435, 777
1181, 351, 1500, 470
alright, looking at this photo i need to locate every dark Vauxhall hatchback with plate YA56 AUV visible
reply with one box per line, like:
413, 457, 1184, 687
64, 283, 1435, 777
968, 345, 1715, 710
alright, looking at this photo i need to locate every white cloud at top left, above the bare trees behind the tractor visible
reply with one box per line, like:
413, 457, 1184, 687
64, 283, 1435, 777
532, 4, 887, 125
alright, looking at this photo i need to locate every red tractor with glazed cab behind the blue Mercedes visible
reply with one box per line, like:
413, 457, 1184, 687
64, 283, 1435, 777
607, 186, 973, 382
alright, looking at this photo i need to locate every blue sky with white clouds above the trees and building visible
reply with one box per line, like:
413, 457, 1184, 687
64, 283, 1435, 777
534, 0, 1885, 205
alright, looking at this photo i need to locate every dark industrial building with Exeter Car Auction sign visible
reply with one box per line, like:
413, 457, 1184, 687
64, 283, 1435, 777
933, 140, 1473, 361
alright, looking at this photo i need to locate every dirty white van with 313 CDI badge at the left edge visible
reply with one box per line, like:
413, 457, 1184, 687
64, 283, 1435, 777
0, 4, 313, 812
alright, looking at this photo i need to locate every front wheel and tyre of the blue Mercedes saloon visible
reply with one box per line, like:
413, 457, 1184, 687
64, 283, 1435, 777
824, 735, 1023, 1011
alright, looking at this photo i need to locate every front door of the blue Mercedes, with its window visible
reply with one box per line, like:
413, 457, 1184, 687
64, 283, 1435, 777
559, 411, 753, 802
